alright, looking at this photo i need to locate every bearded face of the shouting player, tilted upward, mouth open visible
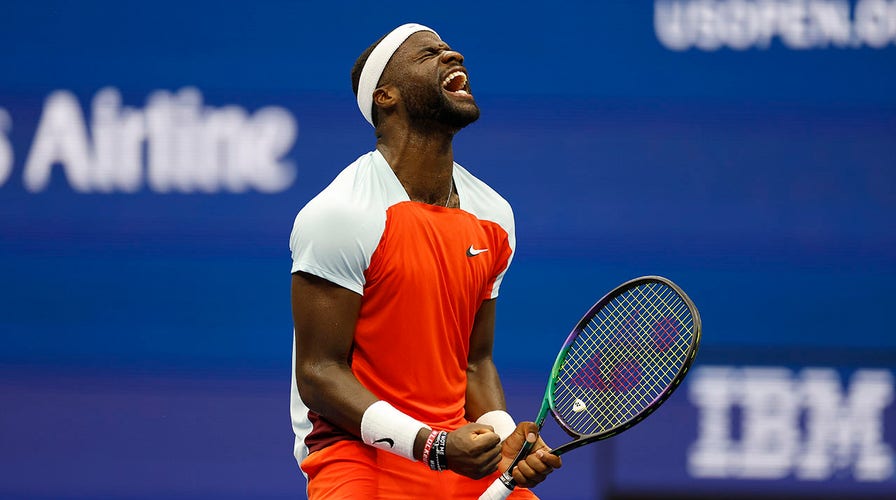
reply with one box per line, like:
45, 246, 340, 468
389, 31, 479, 130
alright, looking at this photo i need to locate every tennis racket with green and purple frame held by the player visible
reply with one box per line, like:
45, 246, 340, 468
479, 276, 701, 500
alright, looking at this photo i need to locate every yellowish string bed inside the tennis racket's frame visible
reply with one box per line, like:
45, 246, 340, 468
553, 282, 694, 435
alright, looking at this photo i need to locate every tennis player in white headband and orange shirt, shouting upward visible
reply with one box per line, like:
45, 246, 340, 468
290, 24, 561, 500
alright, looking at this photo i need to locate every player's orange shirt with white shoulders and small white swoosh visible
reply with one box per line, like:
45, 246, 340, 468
290, 151, 516, 463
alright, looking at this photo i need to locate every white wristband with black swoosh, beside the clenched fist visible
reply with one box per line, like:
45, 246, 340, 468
361, 400, 430, 460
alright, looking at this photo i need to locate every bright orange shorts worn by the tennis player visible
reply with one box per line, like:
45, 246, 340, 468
302, 441, 538, 500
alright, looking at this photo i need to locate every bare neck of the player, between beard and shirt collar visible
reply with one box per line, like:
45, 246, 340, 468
376, 119, 454, 205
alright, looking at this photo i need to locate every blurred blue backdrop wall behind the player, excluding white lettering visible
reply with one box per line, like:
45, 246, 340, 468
0, 0, 896, 498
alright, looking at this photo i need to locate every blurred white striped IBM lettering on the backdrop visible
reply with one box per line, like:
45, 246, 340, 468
688, 367, 894, 482
